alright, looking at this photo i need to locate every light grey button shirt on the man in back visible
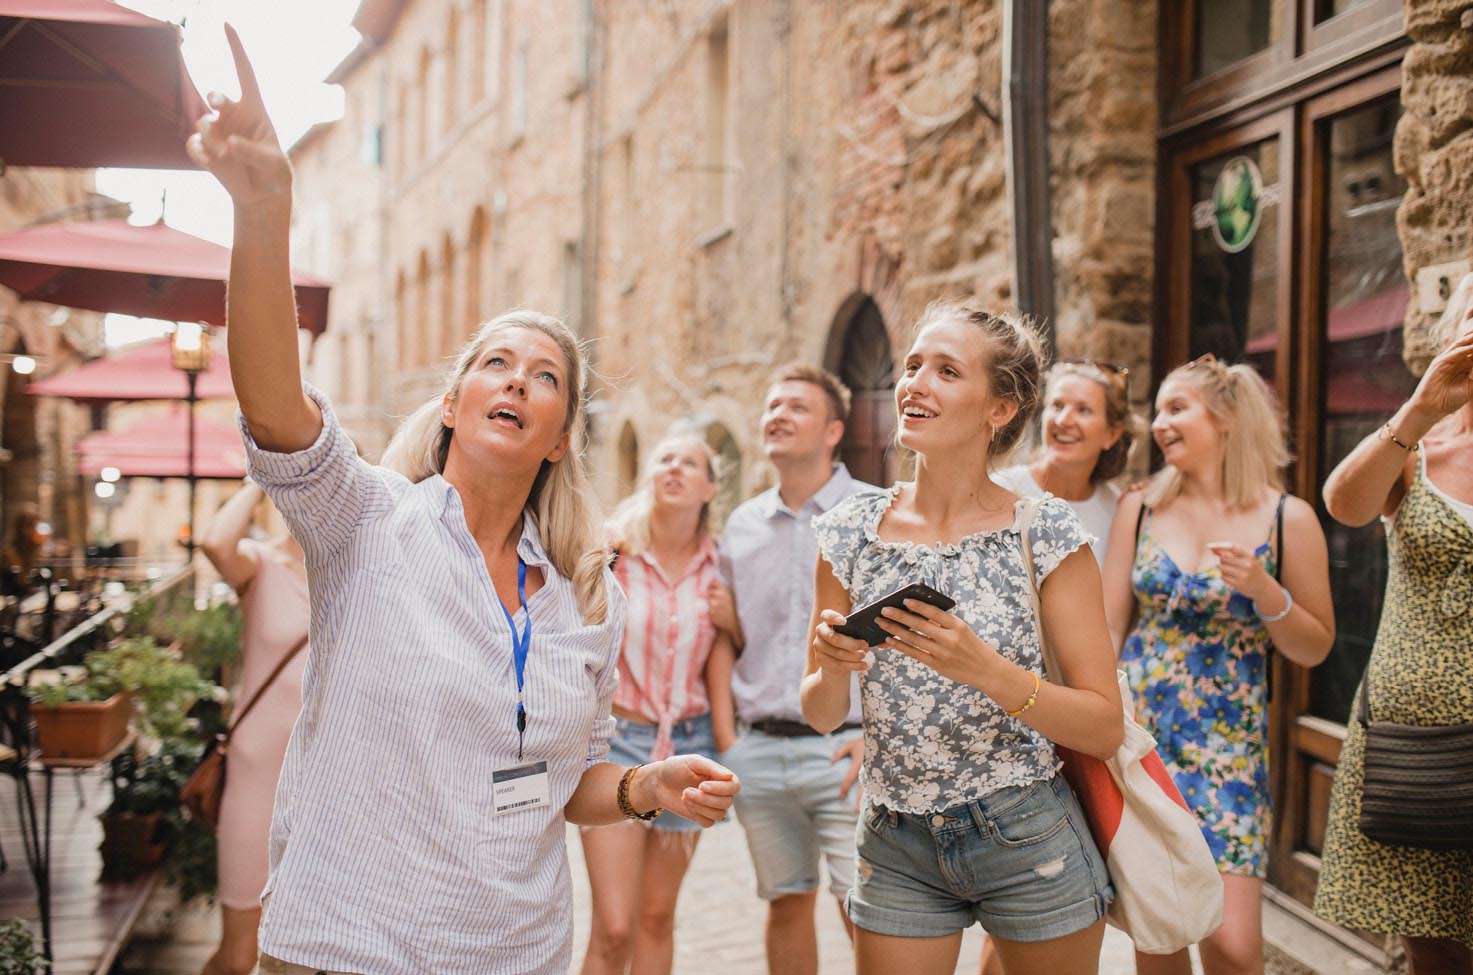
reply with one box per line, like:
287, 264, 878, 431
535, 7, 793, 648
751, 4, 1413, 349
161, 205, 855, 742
722, 464, 878, 723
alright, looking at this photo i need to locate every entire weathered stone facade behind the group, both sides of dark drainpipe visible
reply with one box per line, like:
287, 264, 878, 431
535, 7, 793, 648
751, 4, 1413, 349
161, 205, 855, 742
296, 0, 1156, 512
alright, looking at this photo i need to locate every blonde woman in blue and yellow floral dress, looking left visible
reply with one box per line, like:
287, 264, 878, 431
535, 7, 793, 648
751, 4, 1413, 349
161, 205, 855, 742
1105, 356, 1335, 975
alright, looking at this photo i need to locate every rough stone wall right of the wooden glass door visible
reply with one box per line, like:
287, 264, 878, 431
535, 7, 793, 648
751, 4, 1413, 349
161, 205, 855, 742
1395, 0, 1473, 371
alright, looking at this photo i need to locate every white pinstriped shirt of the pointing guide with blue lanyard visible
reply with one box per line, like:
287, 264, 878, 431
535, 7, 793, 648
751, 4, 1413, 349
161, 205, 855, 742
240, 387, 625, 975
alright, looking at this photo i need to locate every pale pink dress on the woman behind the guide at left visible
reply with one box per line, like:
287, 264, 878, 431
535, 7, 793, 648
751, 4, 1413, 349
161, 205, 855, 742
217, 541, 309, 910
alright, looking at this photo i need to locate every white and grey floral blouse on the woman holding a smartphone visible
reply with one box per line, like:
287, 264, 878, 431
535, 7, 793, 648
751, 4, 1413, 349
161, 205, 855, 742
813, 485, 1090, 814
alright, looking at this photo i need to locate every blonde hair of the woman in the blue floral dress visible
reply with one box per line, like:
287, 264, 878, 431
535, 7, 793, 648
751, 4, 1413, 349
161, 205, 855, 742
1145, 355, 1289, 508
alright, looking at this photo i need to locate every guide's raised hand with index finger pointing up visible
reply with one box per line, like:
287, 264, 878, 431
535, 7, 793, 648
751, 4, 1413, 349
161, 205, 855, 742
186, 24, 292, 208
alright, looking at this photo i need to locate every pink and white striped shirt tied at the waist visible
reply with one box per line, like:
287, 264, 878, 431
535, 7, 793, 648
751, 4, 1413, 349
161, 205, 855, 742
614, 536, 719, 761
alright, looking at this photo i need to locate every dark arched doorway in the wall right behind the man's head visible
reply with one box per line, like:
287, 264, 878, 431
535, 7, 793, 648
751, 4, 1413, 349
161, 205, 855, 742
829, 295, 896, 488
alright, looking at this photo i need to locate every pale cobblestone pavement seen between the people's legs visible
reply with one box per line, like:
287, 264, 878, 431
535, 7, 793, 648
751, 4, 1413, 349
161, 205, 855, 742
115, 823, 1196, 975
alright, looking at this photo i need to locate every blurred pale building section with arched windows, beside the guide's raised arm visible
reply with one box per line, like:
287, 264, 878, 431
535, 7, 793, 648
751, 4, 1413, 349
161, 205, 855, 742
293, 0, 588, 455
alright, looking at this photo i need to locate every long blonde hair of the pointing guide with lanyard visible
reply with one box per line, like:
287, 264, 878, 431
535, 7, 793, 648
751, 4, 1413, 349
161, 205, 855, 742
382, 308, 608, 623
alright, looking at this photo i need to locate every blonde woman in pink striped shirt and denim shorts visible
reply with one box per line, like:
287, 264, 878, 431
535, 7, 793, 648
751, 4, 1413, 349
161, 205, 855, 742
583, 433, 735, 975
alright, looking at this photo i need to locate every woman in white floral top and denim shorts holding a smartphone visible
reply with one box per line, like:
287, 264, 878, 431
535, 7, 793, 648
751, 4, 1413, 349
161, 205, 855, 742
801, 302, 1122, 975
